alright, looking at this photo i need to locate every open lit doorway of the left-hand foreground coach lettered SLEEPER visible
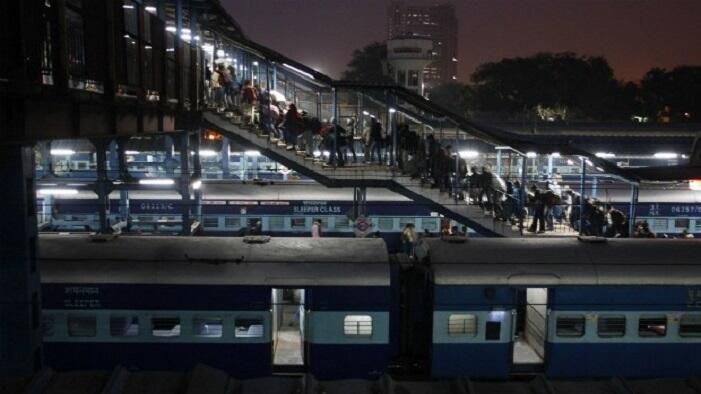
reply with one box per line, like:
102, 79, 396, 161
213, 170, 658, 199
271, 288, 304, 372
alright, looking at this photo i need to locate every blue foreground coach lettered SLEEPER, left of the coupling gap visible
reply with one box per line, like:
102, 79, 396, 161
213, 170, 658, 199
39, 235, 395, 378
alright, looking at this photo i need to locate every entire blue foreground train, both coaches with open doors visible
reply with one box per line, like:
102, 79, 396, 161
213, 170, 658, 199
38, 235, 701, 379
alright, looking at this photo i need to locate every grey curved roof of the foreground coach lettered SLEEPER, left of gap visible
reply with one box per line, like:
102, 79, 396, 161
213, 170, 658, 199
38, 235, 390, 286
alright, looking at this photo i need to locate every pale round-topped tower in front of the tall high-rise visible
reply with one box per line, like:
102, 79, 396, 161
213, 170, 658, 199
385, 36, 433, 95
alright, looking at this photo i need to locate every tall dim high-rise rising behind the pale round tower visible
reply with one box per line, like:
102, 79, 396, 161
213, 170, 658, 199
387, 1, 458, 89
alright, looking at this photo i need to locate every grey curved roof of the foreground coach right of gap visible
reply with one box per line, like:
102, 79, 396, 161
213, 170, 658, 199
427, 238, 701, 286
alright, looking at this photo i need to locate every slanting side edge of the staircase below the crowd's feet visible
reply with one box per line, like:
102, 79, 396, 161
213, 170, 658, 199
203, 111, 520, 237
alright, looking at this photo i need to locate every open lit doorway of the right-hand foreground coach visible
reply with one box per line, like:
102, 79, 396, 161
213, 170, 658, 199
512, 288, 548, 372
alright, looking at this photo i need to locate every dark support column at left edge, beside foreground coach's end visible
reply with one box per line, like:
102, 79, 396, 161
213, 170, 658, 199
0, 145, 42, 376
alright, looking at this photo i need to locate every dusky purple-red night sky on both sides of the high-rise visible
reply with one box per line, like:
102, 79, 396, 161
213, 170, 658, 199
227, 0, 701, 81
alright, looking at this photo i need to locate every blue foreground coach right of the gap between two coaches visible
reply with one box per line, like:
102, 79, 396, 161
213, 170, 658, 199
427, 239, 701, 378
